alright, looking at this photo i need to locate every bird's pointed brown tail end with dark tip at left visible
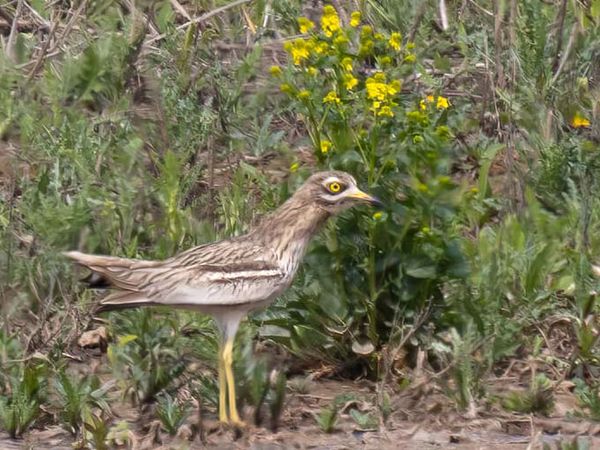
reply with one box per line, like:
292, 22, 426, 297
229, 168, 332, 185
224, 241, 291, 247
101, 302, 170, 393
63, 251, 161, 313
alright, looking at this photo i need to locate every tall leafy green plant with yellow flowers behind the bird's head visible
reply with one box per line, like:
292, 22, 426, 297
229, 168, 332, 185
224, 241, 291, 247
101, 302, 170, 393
268, 6, 468, 366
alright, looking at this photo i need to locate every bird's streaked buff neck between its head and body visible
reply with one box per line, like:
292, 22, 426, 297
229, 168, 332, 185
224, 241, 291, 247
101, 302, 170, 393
254, 198, 330, 270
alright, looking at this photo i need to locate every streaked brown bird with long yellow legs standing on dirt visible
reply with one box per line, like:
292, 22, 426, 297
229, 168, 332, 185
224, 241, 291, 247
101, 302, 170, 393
64, 171, 381, 427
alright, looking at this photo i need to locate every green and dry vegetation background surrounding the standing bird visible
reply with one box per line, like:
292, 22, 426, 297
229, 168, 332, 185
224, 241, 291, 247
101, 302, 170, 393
0, 0, 600, 448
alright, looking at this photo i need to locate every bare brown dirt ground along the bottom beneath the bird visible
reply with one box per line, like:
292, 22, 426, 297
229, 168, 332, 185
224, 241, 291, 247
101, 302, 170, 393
0, 374, 600, 450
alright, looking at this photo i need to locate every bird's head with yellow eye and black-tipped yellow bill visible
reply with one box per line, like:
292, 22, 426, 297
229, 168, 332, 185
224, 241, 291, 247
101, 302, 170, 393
300, 171, 381, 214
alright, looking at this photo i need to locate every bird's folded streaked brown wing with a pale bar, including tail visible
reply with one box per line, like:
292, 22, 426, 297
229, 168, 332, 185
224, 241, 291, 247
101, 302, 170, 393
66, 240, 286, 309
